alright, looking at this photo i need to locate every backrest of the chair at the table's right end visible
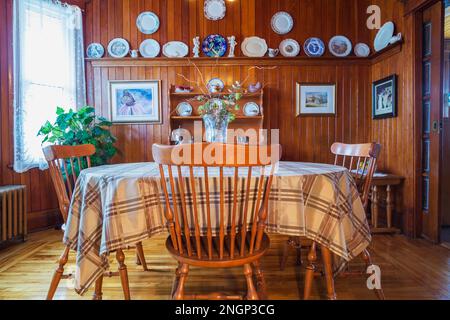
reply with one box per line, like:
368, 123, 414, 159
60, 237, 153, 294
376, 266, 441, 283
331, 143, 381, 208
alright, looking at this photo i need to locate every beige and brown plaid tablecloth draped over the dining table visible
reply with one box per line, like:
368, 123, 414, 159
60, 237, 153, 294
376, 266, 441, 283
64, 162, 371, 294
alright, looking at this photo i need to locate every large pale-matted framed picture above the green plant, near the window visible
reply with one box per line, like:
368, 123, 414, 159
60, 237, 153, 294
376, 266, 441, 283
109, 80, 162, 123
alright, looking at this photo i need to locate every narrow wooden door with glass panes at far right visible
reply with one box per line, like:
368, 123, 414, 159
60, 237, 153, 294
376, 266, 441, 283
422, 1, 444, 243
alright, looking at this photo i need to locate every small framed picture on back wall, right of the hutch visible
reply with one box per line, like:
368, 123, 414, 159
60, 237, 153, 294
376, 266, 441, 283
297, 83, 336, 116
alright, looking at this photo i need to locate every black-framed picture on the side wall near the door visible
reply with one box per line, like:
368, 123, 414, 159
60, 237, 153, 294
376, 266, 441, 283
372, 75, 397, 119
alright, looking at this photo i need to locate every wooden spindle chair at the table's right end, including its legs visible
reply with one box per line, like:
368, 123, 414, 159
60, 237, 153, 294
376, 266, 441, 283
281, 143, 384, 300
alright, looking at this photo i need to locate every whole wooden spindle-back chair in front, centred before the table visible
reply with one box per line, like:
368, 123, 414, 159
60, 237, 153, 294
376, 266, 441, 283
153, 144, 281, 300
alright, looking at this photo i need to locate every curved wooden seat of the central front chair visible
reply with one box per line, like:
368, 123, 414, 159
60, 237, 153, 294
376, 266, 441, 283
166, 232, 270, 268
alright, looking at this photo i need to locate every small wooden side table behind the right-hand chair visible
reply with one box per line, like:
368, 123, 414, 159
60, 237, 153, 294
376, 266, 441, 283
370, 173, 405, 234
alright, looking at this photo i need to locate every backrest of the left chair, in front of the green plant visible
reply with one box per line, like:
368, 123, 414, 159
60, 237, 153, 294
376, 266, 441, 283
43, 144, 95, 223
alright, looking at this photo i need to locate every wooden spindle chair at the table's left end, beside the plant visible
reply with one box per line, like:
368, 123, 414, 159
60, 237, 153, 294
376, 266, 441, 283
43, 144, 148, 300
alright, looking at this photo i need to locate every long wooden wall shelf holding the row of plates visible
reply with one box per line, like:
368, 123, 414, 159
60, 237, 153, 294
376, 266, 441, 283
86, 42, 402, 68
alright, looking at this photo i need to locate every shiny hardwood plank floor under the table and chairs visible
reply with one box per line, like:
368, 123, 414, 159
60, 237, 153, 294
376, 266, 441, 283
0, 230, 450, 300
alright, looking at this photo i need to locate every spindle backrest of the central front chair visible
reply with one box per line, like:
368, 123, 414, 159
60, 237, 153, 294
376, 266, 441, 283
153, 144, 281, 260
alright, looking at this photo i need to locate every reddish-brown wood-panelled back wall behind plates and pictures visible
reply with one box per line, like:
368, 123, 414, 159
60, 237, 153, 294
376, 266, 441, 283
86, 0, 370, 166
